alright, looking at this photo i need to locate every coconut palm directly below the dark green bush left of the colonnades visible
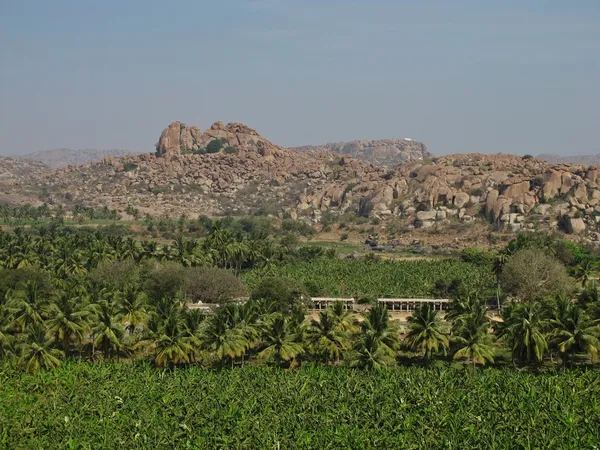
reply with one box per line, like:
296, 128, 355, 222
258, 313, 304, 366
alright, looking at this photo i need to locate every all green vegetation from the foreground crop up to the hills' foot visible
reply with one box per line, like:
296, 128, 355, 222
0, 225, 600, 449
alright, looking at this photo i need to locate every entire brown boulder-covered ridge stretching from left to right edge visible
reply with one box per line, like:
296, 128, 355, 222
5, 122, 600, 240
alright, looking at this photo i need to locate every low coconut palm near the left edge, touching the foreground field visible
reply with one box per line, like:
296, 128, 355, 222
18, 323, 64, 372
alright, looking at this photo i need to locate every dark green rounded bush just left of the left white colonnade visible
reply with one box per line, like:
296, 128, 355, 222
250, 277, 310, 313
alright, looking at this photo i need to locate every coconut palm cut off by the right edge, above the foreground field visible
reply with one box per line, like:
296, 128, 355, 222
549, 303, 600, 367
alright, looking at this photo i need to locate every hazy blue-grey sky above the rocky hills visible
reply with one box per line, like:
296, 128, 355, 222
0, 0, 600, 155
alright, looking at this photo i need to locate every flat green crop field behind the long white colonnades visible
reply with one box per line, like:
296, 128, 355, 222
244, 259, 493, 298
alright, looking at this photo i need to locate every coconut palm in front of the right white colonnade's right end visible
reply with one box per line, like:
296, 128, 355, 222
405, 303, 450, 363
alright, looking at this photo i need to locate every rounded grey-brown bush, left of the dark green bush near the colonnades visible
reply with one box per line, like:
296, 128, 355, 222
183, 267, 246, 303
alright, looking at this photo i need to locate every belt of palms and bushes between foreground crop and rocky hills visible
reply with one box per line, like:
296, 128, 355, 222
0, 225, 600, 371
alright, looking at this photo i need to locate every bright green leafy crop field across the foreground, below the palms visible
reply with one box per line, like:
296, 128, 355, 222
0, 363, 600, 449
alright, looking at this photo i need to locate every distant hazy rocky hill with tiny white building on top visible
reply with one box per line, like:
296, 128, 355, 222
291, 138, 433, 168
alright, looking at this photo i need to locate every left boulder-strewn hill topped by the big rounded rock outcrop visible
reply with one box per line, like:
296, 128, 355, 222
13, 122, 383, 217
